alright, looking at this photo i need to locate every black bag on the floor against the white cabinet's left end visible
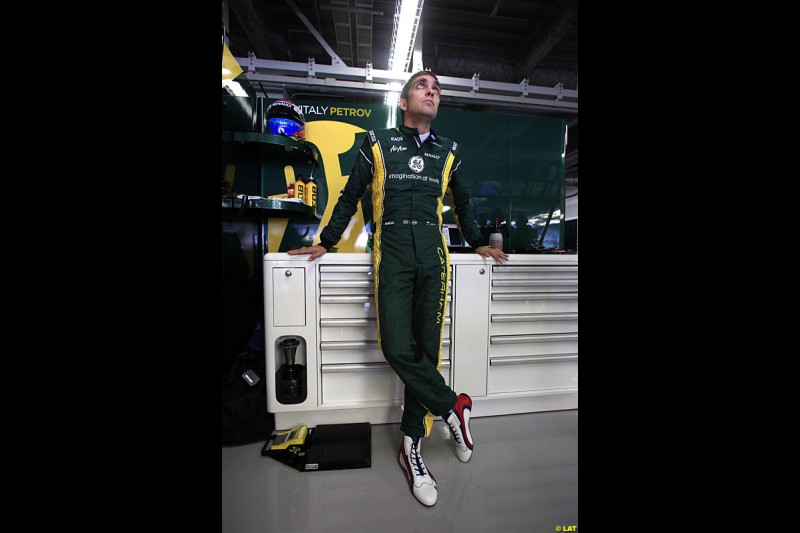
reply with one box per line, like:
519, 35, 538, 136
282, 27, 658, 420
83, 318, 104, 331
222, 349, 275, 446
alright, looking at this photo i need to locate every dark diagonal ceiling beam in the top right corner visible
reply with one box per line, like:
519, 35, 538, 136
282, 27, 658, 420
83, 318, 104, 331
517, 0, 578, 78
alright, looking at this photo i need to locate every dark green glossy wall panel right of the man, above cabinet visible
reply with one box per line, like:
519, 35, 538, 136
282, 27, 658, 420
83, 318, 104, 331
433, 108, 566, 251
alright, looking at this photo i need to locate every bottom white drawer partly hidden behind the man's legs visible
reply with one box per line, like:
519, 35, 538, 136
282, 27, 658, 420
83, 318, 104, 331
321, 361, 450, 404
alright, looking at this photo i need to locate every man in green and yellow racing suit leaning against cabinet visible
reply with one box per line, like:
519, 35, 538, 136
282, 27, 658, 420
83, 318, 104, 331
289, 71, 508, 506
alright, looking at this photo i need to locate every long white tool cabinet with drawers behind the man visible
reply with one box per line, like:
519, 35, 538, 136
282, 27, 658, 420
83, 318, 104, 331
264, 253, 578, 429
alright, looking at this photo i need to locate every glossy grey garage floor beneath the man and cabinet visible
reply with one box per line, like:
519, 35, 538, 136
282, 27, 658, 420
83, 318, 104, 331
222, 410, 578, 533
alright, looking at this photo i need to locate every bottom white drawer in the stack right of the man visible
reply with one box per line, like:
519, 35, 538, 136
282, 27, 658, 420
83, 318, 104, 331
488, 355, 578, 394
